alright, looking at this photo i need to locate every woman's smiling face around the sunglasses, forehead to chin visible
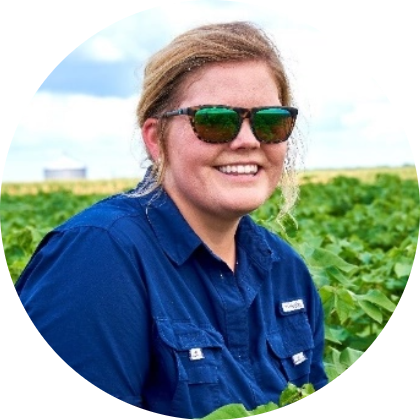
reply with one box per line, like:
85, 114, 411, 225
158, 61, 287, 220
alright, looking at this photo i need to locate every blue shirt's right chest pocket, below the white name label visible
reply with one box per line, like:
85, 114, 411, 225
267, 308, 314, 386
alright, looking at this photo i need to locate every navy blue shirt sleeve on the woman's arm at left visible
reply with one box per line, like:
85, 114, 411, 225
16, 227, 151, 408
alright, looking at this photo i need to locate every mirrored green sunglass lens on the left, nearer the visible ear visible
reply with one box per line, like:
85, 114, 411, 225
194, 107, 240, 143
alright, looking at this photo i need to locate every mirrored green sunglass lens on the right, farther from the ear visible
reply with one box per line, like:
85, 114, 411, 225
252, 108, 294, 143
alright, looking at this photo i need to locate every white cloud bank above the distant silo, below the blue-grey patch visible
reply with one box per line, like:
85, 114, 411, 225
3, 92, 143, 180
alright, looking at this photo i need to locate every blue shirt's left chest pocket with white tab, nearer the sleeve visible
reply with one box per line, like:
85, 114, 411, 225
157, 320, 223, 384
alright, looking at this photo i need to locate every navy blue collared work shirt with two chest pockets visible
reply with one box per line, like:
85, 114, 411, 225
16, 183, 327, 419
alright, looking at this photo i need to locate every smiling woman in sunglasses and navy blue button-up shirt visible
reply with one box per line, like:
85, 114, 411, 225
16, 22, 327, 419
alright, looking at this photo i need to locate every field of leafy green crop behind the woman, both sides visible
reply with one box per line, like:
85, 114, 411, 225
0, 168, 420, 418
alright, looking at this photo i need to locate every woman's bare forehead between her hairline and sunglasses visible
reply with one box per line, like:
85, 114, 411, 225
180, 61, 280, 107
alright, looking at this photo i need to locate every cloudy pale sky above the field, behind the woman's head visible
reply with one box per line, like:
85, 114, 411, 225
2, 0, 415, 182
